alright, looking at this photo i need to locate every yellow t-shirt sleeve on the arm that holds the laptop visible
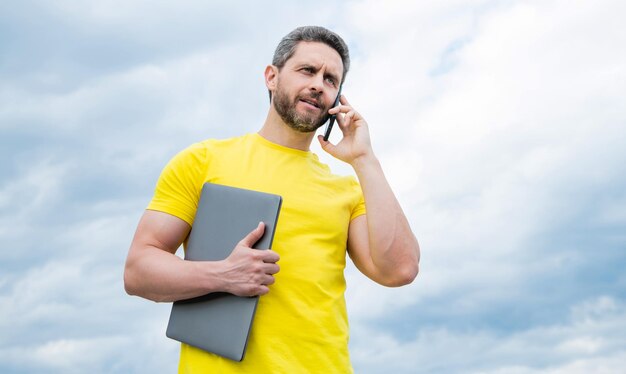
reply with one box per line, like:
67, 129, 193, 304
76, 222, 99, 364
147, 143, 208, 225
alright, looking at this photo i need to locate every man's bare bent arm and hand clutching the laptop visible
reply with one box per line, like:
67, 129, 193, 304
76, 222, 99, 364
124, 210, 279, 301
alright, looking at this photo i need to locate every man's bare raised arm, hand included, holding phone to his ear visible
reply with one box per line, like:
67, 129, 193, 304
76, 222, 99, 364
318, 96, 420, 286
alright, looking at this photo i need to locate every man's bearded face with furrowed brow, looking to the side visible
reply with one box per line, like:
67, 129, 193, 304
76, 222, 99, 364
272, 42, 343, 132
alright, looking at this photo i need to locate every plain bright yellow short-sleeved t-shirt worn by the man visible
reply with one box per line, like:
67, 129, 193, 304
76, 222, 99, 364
148, 134, 365, 374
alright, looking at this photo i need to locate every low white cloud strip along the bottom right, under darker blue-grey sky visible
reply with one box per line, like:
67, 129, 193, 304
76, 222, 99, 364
352, 296, 626, 374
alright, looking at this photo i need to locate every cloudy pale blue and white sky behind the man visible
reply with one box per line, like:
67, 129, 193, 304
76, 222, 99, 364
0, 0, 626, 374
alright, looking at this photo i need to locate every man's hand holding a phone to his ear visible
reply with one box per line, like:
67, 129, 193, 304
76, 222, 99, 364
317, 95, 374, 166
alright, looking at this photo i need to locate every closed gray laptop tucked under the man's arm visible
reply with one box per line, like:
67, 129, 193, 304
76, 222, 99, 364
166, 183, 282, 361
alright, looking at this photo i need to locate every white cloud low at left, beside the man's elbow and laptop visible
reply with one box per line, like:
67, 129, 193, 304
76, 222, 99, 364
0, 207, 179, 373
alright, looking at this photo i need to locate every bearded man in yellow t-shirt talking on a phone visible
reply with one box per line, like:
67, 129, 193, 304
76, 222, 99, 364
124, 27, 419, 373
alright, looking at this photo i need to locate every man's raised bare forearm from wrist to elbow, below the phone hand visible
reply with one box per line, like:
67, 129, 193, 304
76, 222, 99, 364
352, 155, 419, 280
